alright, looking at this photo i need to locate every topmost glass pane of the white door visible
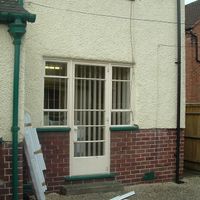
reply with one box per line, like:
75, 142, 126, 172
75, 65, 105, 79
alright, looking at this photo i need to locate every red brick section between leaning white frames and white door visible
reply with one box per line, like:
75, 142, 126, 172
38, 132, 69, 192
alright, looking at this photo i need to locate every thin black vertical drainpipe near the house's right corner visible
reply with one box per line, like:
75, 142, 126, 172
176, 0, 181, 184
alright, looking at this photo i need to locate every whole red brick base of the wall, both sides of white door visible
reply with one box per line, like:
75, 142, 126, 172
24, 129, 184, 192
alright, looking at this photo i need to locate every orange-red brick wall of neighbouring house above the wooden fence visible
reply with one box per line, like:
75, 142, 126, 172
185, 23, 200, 103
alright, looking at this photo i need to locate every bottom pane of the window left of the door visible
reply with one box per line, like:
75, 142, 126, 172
44, 111, 67, 126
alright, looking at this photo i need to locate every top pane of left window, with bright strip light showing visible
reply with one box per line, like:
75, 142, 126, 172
45, 62, 67, 76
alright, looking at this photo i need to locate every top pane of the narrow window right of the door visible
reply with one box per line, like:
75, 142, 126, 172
112, 67, 130, 80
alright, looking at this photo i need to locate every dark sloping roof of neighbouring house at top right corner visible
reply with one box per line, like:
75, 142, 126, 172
185, 0, 200, 30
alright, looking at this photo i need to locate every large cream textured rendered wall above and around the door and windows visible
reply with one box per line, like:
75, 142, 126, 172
25, 0, 185, 128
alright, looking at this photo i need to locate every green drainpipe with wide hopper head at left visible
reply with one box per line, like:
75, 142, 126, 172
8, 18, 26, 200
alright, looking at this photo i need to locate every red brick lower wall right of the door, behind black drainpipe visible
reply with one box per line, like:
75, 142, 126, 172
111, 129, 184, 184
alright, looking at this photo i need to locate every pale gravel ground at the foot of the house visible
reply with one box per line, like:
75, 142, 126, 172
46, 175, 200, 200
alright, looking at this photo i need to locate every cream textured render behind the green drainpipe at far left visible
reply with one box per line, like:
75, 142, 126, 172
0, 25, 24, 141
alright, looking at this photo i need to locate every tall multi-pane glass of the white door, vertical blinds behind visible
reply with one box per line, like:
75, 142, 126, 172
74, 65, 105, 157
